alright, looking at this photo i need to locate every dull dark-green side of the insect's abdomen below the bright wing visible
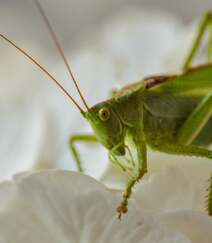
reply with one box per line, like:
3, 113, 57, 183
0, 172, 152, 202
143, 96, 212, 146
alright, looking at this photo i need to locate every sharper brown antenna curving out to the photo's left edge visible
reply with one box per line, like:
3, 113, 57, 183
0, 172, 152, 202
0, 34, 85, 113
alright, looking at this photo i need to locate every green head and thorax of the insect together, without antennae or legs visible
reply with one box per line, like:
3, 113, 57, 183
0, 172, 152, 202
85, 81, 144, 154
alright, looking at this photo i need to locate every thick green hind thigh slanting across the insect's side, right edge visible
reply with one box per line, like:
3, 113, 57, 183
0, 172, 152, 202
177, 91, 212, 145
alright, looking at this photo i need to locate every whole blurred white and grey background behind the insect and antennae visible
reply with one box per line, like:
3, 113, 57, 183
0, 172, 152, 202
0, 0, 212, 180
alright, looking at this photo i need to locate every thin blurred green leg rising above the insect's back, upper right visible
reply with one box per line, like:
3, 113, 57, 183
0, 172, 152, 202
182, 11, 212, 70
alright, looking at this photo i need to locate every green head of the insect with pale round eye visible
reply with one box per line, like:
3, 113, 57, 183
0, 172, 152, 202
84, 102, 125, 155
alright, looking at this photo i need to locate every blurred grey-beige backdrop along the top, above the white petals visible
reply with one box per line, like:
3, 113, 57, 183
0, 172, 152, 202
0, 0, 212, 48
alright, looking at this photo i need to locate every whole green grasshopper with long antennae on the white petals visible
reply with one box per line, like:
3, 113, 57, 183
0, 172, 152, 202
0, 0, 212, 217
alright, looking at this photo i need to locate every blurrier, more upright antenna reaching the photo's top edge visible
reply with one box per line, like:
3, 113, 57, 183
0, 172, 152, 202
34, 0, 89, 110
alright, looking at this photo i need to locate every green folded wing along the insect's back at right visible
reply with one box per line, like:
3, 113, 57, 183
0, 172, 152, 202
145, 64, 212, 118
